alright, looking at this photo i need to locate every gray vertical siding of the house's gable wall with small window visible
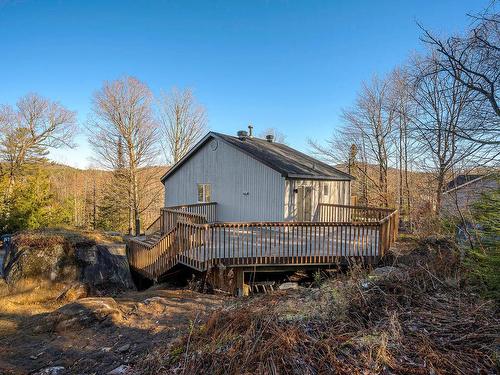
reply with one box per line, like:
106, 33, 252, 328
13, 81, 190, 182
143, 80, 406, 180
165, 140, 285, 221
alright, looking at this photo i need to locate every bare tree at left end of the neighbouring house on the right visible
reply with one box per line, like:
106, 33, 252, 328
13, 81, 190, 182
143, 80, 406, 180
412, 56, 483, 212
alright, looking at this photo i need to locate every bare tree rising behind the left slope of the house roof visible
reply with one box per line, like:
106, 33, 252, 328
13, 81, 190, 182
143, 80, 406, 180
159, 88, 207, 164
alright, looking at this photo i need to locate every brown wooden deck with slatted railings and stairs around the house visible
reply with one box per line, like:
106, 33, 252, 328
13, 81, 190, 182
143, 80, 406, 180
128, 203, 397, 279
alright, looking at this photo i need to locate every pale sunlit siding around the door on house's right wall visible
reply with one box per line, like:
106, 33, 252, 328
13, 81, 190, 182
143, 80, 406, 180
285, 180, 351, 221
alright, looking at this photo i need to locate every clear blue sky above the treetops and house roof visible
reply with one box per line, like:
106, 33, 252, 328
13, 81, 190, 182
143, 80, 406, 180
0, 0, 488, 167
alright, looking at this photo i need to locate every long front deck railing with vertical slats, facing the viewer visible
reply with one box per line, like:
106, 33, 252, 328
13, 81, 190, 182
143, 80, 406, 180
177, 222, 380, 270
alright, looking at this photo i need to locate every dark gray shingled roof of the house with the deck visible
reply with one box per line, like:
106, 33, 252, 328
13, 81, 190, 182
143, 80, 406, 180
161, 132, 354, 181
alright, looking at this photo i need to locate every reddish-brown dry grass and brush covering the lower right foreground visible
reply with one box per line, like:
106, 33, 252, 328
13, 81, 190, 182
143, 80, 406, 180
137, 239, 500, 374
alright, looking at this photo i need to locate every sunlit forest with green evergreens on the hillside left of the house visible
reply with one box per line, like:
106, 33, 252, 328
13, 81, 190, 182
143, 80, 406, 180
0, 161, 166, 233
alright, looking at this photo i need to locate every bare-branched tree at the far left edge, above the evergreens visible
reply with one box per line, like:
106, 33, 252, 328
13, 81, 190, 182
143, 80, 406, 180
0, 94, 76, 192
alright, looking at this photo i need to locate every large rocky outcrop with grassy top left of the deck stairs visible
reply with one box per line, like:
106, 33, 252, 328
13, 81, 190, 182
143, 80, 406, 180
4, 232, 135, 299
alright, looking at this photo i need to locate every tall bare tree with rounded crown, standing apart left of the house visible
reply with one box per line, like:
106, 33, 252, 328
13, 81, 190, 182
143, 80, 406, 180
88, 77, 159, 235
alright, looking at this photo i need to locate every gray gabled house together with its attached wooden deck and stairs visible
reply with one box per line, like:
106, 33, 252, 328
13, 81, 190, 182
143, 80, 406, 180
127, 129, 398, 294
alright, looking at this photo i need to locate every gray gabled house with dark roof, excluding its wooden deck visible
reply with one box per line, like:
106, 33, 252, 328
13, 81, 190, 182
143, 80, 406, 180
161, 129, 353, 222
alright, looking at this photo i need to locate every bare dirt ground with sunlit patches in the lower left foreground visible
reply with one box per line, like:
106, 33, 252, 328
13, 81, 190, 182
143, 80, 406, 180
0, 284, 227, 374
